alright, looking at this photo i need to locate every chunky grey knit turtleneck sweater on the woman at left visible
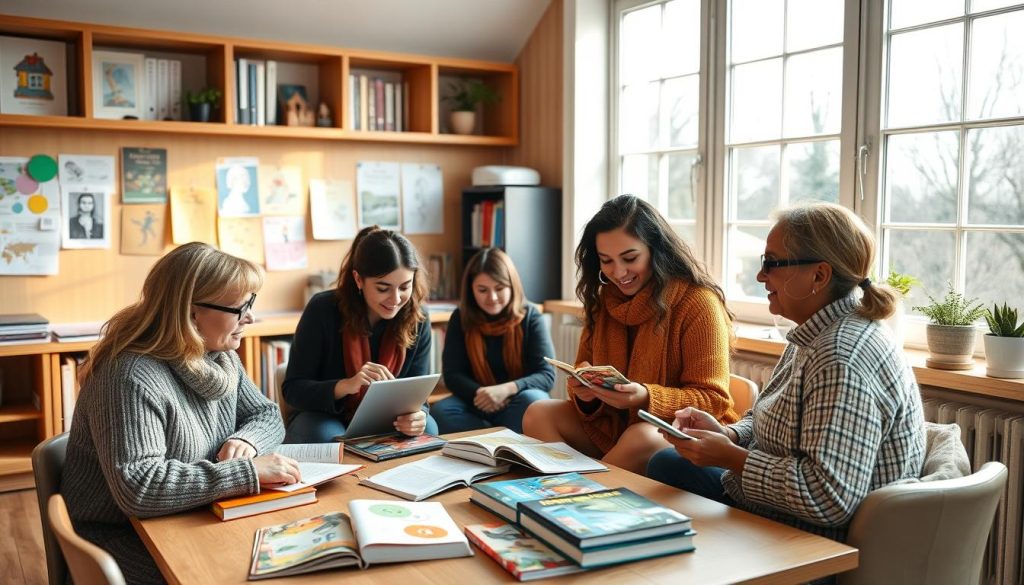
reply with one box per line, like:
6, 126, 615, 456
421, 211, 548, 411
60, 351, 285, 583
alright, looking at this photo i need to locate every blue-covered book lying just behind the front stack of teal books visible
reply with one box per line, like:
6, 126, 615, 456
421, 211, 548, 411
469, 473, 607, 523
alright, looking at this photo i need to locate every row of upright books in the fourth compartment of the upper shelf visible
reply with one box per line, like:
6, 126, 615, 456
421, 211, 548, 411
348, 73, 409, 132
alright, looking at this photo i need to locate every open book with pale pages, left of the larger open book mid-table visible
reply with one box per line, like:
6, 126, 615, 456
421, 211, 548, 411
359, 455, 509, 502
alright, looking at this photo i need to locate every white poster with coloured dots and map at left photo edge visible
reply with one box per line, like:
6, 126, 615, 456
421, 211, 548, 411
0, 157, 60, 276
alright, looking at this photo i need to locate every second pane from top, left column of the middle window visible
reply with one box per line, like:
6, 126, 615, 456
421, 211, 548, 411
729, 58, 782, 142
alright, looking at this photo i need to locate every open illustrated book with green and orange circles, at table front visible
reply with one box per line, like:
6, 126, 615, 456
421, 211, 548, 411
249, 500, 473, 580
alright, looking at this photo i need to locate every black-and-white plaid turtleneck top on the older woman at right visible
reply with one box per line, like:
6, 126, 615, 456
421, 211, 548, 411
722, 296, 925, 540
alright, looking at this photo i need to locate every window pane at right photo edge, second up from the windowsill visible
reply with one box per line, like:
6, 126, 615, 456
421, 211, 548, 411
967, 126, 1024, 224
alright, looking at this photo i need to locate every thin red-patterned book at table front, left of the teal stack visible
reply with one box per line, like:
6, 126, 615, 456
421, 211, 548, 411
466, 523, 583, 581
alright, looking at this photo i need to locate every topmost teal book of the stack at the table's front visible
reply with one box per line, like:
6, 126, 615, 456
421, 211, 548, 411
518, 488, 690, 549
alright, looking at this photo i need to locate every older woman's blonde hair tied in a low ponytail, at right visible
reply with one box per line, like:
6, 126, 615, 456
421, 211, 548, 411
775, 202, 899, 321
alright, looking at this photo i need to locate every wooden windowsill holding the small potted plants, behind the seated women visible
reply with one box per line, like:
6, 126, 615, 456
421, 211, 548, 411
544, 300, 1024, 402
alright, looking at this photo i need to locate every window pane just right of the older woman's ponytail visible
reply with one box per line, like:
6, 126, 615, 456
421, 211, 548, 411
886, 229, 956, 301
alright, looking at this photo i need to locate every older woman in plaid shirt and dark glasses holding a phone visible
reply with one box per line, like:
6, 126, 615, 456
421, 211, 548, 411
647, 203, 925, 540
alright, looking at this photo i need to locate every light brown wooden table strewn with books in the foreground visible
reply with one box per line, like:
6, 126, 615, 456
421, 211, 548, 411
132, 431, 857, 585
